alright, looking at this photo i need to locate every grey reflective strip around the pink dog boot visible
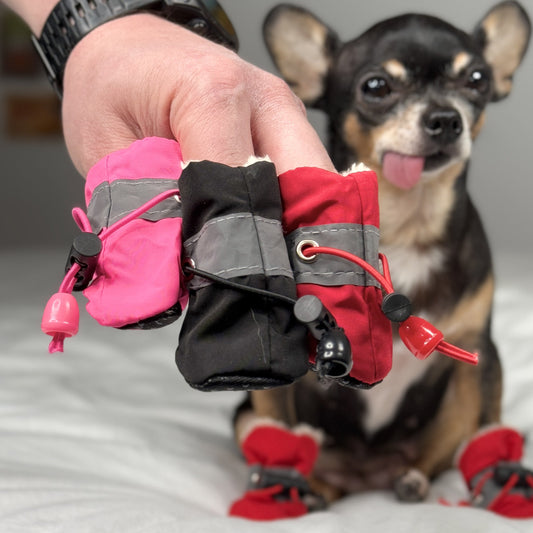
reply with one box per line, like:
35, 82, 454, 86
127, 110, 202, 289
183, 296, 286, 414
87, 178, 181, 233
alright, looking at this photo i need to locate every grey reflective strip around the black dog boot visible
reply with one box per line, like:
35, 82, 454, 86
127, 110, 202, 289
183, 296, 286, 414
183, 213, 293, 289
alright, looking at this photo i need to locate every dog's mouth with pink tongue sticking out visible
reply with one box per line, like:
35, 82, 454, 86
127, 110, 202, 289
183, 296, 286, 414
382, 152, 452, 190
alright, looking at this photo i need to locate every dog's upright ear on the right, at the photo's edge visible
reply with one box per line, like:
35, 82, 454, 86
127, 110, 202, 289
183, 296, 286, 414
473, 0, 531, 101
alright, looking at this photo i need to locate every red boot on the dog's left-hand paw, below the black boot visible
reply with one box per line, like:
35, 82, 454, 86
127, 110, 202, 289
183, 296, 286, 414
229, 425, 324, 520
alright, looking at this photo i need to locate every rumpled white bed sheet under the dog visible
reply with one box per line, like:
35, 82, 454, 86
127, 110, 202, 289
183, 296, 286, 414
0, 250, 533, 533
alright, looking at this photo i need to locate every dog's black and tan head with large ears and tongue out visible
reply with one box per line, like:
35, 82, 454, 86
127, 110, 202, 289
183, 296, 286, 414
264, 2, 530, 244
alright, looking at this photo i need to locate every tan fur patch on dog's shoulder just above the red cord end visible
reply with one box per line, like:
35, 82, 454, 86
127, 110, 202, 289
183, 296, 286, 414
435, 275, 494, 342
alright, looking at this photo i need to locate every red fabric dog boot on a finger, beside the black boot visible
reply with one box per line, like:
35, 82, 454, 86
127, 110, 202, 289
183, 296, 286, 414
279, 163, 392, 387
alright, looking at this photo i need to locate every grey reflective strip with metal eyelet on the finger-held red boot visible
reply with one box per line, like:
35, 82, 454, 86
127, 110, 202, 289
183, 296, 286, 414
286, 224, 379, 286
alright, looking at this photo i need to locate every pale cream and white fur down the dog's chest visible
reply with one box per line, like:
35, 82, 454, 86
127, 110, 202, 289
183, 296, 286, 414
361, 181, 453, 436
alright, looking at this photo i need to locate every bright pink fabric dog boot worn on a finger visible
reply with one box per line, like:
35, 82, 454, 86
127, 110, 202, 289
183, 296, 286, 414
84, 137, 187, 329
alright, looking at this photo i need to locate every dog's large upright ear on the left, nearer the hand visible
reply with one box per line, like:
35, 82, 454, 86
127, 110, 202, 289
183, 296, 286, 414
263, 4, 339, 107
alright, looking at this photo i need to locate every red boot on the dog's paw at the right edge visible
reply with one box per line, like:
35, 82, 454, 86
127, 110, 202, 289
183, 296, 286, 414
458, 427, 533, 518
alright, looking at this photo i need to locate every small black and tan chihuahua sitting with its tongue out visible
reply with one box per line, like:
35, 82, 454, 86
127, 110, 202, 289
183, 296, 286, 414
236, 1, 530, 501
